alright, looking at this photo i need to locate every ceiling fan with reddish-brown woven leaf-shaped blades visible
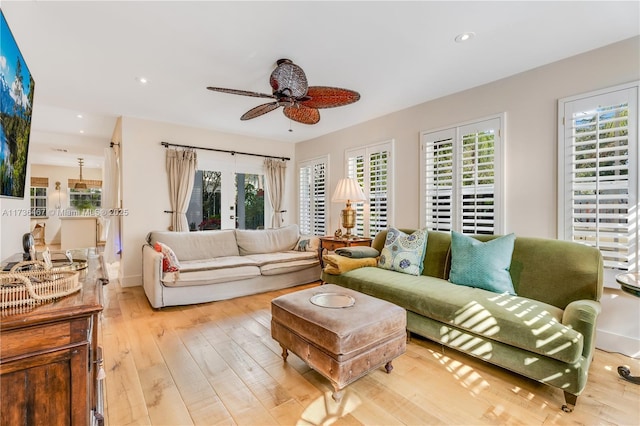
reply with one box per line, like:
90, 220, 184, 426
207, 59, 360, 124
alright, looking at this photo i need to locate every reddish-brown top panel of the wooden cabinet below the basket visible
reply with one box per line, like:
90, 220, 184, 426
0, 318, 90, 362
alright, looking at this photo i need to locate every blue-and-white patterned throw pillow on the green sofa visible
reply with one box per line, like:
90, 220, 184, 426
378, 228, 427, 275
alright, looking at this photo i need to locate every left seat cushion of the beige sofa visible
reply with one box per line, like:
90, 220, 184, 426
162, 266, 260, 287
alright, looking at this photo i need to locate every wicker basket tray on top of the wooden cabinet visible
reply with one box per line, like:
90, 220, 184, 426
0, 261, 82, 310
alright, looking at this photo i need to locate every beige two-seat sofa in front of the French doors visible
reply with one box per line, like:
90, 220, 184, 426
142, 225, 320, 308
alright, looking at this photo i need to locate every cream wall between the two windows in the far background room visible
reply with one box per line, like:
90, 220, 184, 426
31, 164, 102, 244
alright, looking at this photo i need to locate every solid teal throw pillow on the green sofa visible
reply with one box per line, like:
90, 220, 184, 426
449, 231, 516, 295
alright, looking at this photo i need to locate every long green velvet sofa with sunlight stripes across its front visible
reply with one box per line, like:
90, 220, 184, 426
321, 229, 603, 412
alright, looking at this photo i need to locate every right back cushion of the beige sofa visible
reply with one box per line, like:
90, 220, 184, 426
235, 225, 300, 255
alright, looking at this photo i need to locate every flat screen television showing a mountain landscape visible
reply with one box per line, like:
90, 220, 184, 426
0, 10, 35, 198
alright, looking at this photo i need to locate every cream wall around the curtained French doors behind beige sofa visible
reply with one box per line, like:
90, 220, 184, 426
120, 117, 297, 286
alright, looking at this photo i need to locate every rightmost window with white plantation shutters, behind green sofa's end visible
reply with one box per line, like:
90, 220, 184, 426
558, 82, 639, 271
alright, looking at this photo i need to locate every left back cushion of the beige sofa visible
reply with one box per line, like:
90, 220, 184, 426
149, 229, 240, 264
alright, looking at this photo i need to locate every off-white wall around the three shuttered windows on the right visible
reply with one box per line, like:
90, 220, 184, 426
296, 37, 640, 238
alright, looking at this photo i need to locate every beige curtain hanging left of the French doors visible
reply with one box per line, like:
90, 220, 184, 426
167, 148, 198, 232
